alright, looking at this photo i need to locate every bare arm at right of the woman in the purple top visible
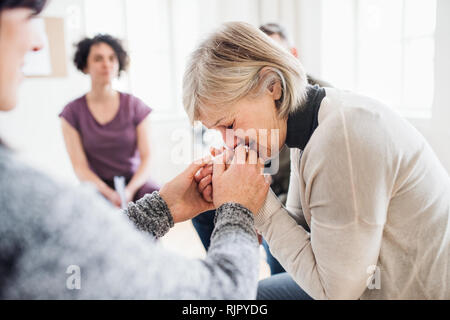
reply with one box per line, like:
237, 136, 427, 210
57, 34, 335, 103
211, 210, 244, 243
125, 116, 150, 202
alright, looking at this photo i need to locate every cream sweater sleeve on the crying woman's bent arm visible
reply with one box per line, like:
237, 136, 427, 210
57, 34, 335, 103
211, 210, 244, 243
255, 110, 391, 299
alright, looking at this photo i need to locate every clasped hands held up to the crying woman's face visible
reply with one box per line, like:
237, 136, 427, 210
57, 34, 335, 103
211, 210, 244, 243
160, 146, 270, 222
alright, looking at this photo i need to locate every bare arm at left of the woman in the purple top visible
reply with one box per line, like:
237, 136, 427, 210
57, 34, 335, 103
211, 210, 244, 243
61, 118, 121, 207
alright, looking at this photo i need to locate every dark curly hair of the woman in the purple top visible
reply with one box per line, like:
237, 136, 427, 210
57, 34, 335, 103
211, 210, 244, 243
73, 34, 129, 76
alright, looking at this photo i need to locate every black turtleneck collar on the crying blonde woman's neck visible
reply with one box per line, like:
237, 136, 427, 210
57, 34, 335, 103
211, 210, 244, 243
286, 85, 326, 150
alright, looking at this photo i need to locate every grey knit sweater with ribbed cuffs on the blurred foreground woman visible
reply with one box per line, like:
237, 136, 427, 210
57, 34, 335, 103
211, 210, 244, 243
0, 168, 259, 299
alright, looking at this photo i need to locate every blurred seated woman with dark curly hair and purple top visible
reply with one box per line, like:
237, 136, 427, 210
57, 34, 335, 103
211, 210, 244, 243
60, 35, 158, 206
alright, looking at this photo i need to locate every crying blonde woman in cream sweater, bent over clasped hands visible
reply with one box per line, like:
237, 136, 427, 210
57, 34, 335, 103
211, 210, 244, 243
190, 23, 450, 299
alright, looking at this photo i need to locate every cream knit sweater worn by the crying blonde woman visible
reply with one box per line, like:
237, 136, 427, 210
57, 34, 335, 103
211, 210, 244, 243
255, 88, 450, 299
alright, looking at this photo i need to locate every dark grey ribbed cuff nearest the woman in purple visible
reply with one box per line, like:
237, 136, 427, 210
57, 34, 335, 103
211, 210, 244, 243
125, 191, 174, 238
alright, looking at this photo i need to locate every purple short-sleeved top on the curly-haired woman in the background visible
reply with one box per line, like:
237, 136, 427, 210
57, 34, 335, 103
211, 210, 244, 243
59, 93, 152, 180
